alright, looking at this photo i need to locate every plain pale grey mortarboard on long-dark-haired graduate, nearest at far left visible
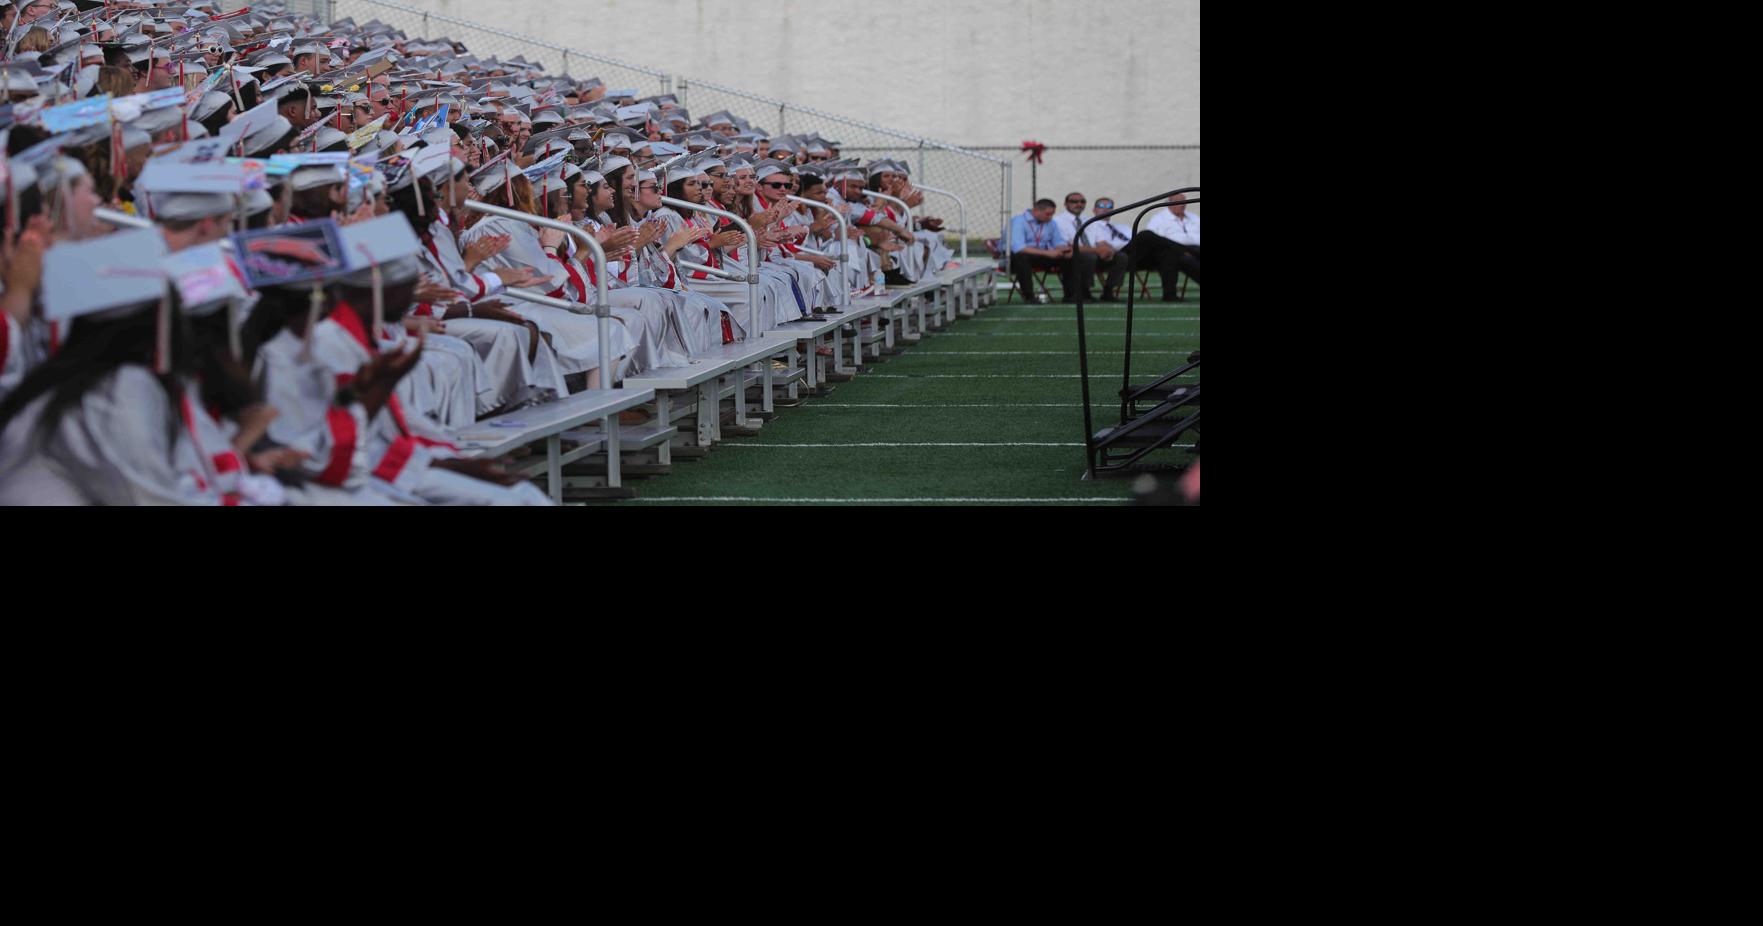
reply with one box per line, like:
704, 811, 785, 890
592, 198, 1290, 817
42, 228, 166, 321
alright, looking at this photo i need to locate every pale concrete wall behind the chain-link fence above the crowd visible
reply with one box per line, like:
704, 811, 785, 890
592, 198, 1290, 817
407, 0, 1201, 210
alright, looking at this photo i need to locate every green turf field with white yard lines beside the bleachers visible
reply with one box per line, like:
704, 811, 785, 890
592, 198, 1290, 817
619, 277, 1201, 506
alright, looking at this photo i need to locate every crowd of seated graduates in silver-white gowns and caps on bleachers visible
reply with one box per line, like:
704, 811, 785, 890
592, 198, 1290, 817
0, 0, 952, 504
